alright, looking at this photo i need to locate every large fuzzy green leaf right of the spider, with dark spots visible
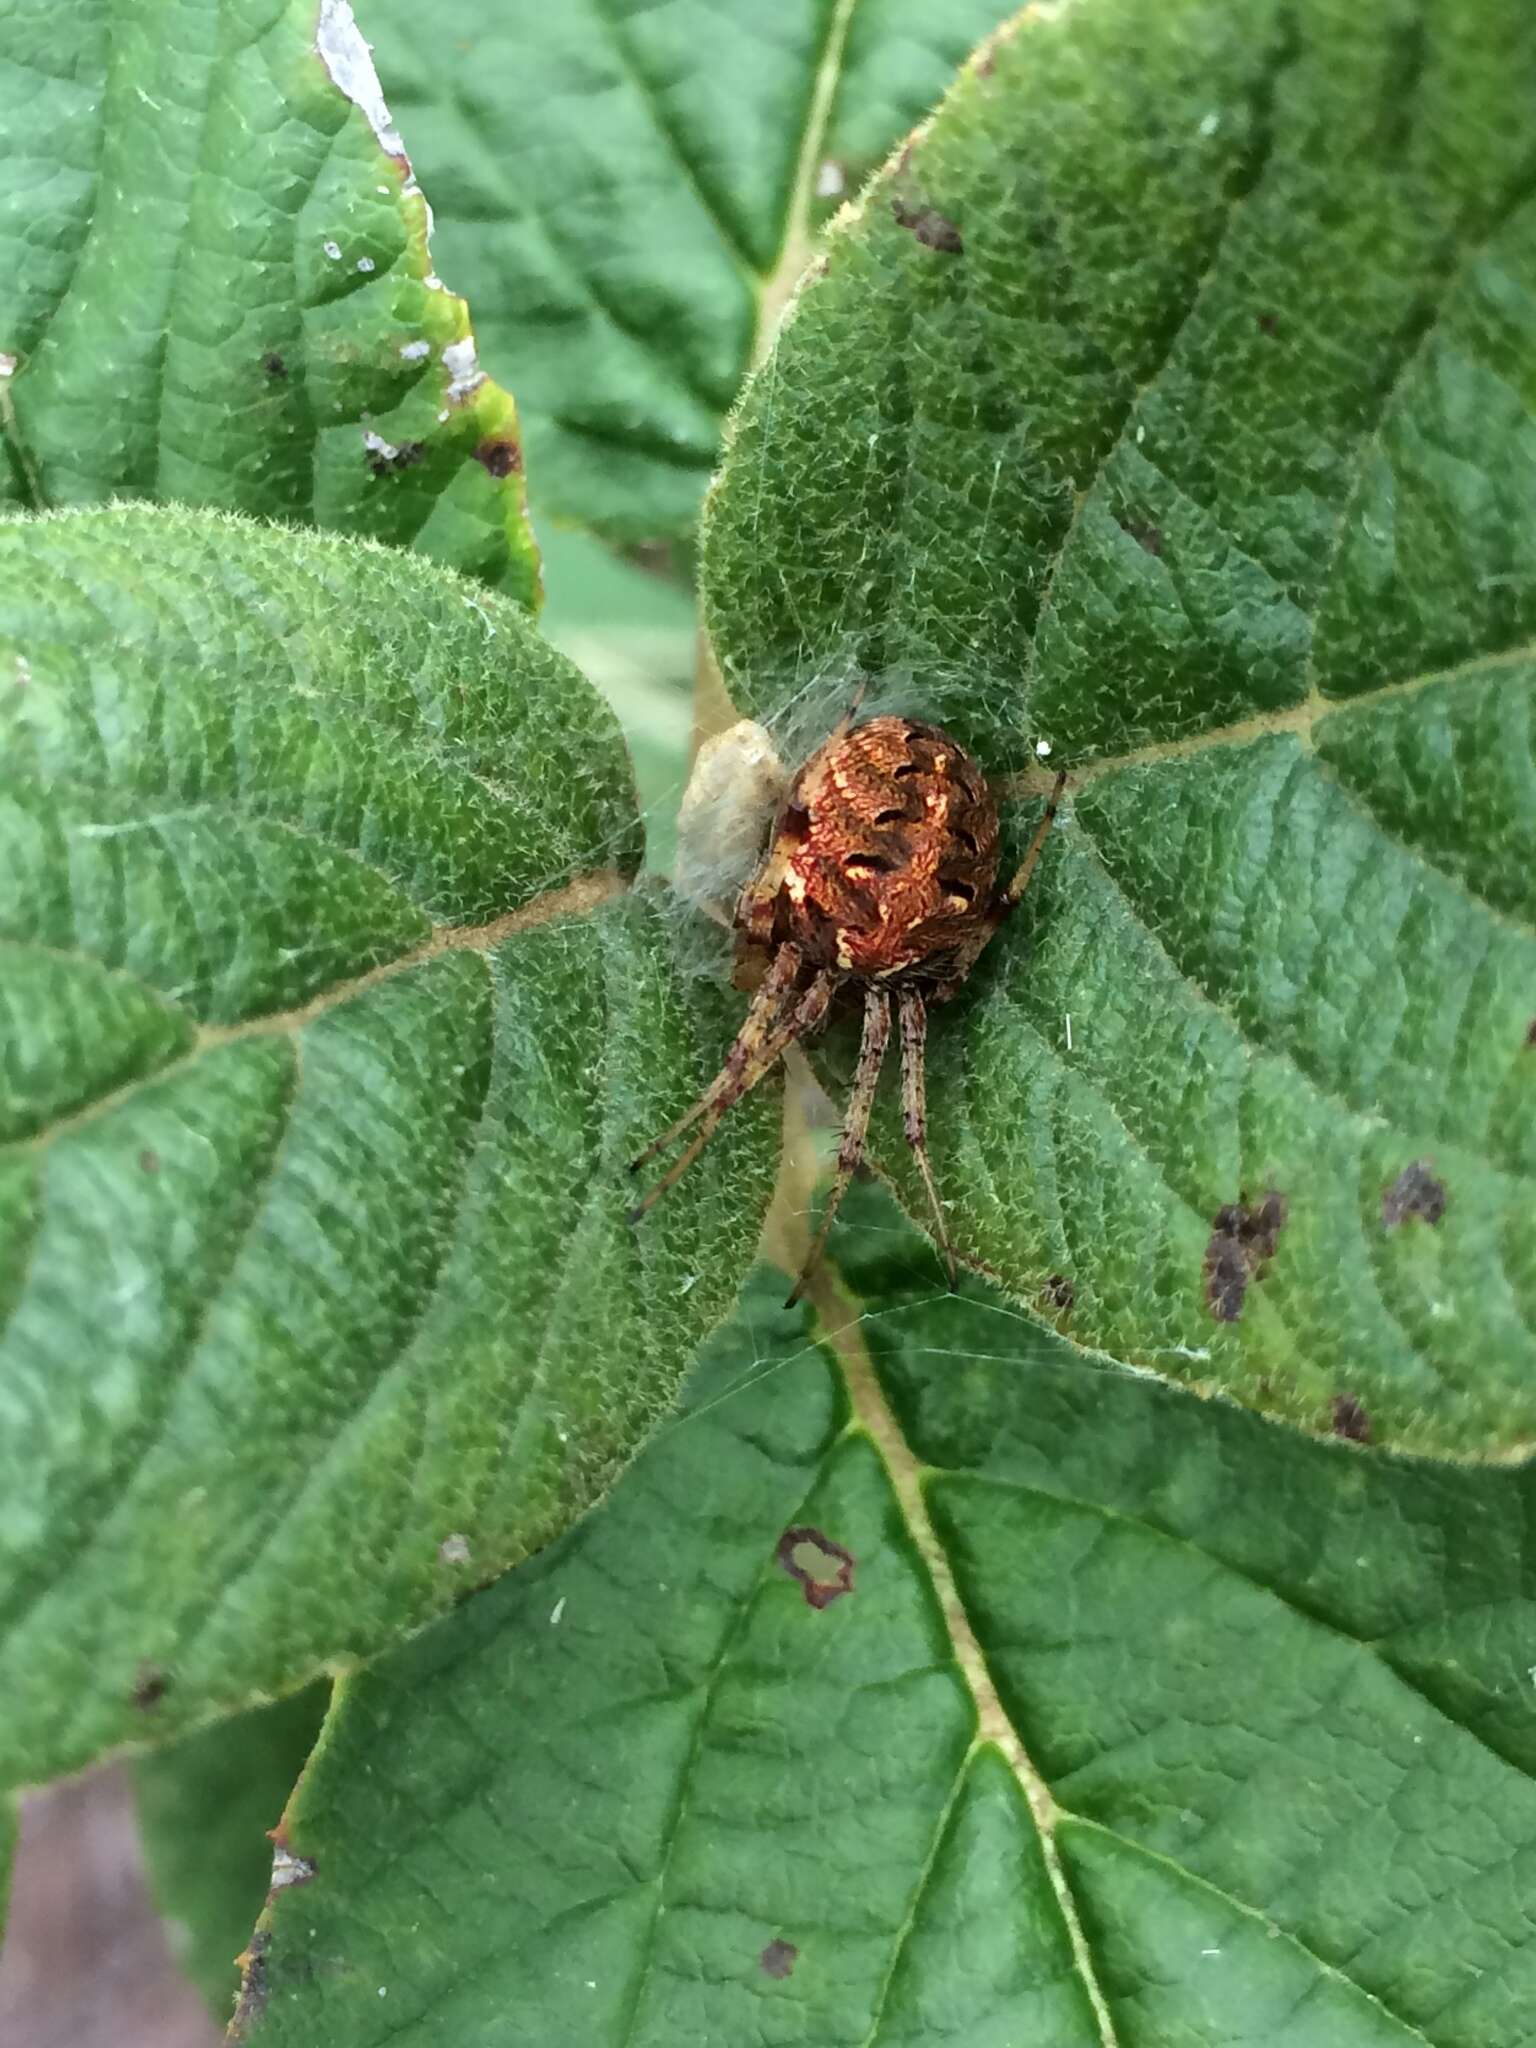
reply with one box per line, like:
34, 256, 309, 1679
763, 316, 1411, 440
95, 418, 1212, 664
705, 0, 1536, 1454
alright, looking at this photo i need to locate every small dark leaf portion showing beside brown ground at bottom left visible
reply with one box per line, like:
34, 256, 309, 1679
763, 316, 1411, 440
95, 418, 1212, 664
133, 1683, 330, 2025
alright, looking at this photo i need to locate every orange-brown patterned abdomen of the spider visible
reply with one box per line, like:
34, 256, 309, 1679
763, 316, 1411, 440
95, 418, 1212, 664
737, 717, 997, 999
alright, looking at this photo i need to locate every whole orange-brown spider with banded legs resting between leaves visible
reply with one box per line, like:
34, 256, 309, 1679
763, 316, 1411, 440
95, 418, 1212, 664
631, 707, 1067, 1307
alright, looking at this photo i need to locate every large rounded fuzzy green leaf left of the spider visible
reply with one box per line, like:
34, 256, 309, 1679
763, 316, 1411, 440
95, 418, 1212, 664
0, 508, 772, 1784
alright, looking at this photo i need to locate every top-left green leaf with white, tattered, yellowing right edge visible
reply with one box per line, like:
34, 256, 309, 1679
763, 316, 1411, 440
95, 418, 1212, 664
0, 0, 539, 602
